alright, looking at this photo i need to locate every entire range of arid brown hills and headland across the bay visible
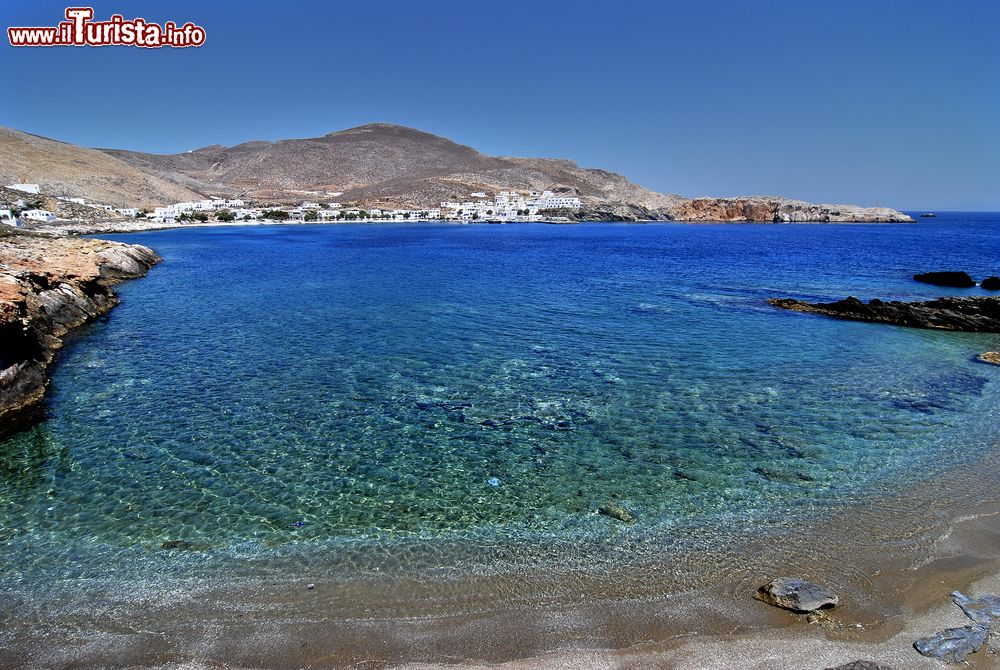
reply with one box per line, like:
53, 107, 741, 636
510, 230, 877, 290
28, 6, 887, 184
0, 123, 911, 222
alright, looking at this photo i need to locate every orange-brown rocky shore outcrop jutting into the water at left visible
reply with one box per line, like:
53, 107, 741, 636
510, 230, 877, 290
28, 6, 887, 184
0, 232, 160, 435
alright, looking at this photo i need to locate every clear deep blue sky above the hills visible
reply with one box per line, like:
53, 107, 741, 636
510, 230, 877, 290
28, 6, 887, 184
0, 0, 1000, 210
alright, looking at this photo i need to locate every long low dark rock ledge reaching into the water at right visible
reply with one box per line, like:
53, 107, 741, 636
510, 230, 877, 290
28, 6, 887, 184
768, 297, 1000, 333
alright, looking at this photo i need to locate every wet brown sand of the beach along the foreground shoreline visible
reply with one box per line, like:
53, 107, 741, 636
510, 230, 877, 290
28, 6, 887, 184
0, 440, 1000, 670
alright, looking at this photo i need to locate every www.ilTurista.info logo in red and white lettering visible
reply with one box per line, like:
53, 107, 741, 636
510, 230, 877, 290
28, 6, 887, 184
7, 7, 205, 49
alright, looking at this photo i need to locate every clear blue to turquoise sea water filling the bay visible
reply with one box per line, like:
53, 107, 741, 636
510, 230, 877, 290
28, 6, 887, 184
0, 214, 1000, 584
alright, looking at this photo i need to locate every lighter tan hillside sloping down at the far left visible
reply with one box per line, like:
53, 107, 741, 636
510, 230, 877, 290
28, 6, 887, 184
0, 128, 200, 207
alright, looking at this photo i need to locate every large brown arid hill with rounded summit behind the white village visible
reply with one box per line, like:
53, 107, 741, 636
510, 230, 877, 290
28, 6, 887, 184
103, 123, 677, 208
